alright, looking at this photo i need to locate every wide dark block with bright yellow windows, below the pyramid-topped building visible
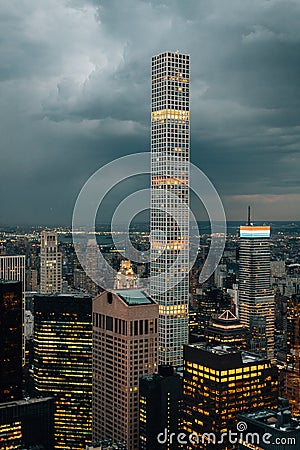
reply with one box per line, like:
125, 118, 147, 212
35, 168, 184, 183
183, 344, 278, 450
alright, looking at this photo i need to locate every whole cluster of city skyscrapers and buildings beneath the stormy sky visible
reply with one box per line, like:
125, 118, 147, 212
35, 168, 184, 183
0, 52, 300, 450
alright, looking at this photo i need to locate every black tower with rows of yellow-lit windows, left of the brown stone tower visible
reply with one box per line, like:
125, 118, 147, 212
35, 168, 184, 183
34, 294, 92, 450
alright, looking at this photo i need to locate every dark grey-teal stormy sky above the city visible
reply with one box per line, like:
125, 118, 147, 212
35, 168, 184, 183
0, 0, 300, 225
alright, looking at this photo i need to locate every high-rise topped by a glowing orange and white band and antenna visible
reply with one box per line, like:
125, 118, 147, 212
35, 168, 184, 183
239, 220, 275, 358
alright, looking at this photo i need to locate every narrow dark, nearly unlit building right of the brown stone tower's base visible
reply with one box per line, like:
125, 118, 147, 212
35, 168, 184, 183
139, 366, 183, 450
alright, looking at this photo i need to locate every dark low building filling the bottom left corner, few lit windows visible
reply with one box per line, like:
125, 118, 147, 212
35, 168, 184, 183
0, 397, 54, 450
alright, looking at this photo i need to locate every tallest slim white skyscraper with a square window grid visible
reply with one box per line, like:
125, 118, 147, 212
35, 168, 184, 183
150, 52, 190, 366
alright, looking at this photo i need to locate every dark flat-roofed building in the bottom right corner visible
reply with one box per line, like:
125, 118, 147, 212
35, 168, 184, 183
238, 409, 300, 450
